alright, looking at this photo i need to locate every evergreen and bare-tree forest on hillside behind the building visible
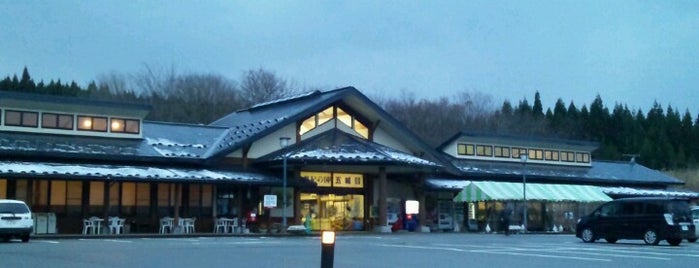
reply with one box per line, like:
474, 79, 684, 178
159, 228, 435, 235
0, 66, 699, 174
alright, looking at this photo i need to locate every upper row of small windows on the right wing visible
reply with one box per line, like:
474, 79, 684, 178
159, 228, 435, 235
457, 143, 590, 163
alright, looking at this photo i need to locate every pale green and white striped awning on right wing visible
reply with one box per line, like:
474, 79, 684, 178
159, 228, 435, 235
454, 181, 612, 202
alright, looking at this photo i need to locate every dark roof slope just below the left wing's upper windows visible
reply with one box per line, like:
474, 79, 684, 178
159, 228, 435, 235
0, 122, 227, 161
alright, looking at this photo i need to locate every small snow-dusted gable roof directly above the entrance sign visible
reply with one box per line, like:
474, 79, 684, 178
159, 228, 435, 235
258, 129, 440, 167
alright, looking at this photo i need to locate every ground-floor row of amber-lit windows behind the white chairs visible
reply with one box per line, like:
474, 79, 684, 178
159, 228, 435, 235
0, 179, 213, 217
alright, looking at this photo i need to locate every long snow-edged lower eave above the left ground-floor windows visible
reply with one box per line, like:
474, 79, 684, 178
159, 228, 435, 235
0, 161, 280, 184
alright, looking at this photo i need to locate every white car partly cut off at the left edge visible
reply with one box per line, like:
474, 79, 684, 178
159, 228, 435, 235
0, 199, 34, 242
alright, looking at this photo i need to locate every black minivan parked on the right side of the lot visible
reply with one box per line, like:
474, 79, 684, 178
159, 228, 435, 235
575, 197, 696, 246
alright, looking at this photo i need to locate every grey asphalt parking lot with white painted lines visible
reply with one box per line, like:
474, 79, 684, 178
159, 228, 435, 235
0, 233, 699, 268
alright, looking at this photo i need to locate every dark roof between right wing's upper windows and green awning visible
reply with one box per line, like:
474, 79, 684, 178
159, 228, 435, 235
454, 160, 684, 186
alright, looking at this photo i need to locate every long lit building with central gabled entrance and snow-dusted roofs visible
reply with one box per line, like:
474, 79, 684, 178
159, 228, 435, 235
0, 87, 696, 233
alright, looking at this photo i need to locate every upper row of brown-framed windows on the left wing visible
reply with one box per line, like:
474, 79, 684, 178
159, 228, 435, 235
3, 110, 141, 134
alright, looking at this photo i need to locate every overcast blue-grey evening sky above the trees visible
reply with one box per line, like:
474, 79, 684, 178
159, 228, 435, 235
0, 0, 699, 113
